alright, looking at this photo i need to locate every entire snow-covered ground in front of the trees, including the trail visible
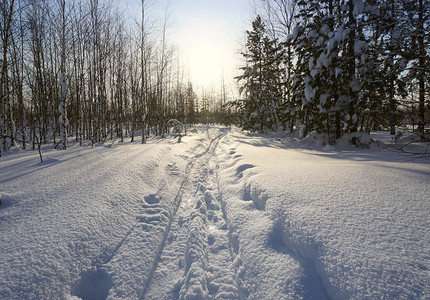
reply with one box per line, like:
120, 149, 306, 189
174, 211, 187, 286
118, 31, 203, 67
0, 127, 430, 299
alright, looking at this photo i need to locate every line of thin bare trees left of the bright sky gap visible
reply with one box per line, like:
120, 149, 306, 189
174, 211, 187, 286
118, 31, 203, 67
0, 0, 225, 156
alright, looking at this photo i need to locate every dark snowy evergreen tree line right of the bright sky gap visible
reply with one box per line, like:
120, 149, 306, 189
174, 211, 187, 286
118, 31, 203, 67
230, 0, 430, 143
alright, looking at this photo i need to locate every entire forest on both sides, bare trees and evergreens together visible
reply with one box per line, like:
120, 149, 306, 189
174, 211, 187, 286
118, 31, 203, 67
0, 0, 430, 155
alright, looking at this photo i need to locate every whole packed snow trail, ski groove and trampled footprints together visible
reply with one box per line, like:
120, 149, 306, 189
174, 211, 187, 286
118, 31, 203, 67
140, 132, 238, 299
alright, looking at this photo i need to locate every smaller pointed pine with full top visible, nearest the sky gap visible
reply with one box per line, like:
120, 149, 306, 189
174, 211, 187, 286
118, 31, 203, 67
237, 16, 284, 132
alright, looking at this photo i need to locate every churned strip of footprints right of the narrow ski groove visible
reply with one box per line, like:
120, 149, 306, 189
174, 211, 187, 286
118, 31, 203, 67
179, 132, 239, 299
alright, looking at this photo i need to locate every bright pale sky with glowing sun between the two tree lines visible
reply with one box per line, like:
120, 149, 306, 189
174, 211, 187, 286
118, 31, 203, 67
121, 0, 254, 98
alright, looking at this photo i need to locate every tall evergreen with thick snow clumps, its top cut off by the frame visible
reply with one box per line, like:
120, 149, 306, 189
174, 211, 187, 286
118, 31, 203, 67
293, 0, 386, 143
